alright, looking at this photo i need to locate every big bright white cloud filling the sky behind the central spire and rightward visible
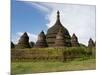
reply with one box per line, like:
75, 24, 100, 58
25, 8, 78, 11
44, 3, 96, 45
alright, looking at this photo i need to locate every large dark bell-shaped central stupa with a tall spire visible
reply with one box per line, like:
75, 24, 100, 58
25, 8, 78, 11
46, 11, 71, 47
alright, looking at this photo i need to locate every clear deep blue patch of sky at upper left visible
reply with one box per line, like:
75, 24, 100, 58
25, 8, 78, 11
11, 0, 48, 41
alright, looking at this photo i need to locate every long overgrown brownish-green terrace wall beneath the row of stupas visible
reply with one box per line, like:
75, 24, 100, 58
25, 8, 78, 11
11, 47, 95, 61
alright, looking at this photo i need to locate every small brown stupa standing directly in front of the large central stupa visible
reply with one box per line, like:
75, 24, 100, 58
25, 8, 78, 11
54, 28, 66, 47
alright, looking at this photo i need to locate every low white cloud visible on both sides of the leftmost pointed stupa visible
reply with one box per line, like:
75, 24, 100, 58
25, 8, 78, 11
12, 32, 38, 44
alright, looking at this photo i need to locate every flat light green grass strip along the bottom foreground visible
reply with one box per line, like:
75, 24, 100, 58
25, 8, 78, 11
11, 58, 96, 75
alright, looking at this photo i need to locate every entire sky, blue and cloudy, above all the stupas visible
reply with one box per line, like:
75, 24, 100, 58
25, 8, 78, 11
11, 0, 96, 45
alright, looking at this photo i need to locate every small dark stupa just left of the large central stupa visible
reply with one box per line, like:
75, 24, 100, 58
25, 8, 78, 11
35, 31, 47, 48
